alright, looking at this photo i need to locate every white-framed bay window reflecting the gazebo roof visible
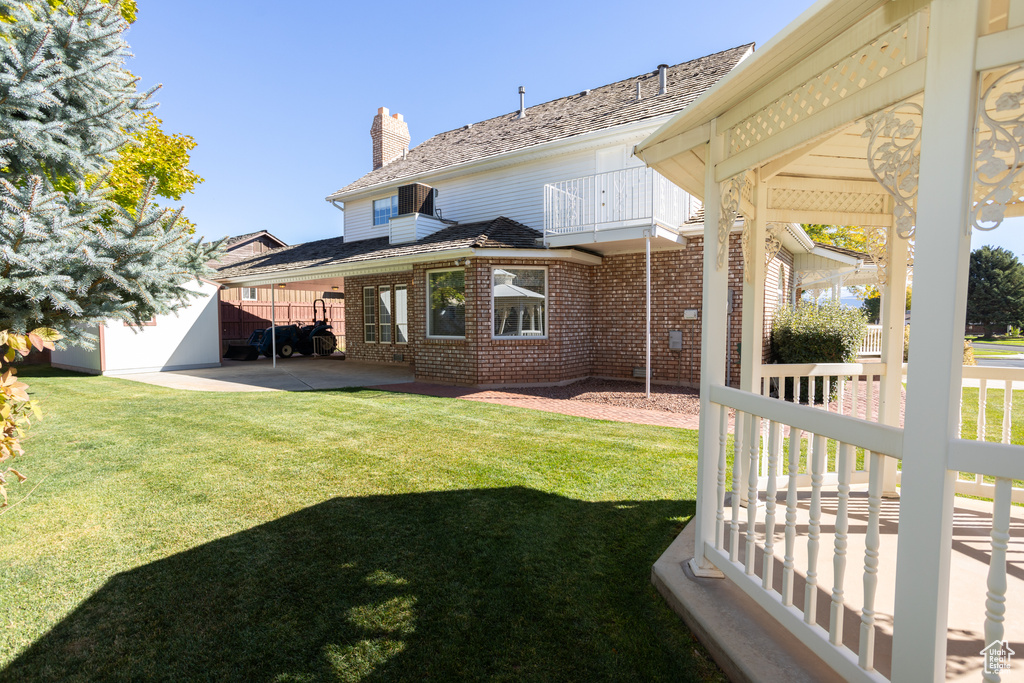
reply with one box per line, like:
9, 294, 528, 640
490, 266, 548, 339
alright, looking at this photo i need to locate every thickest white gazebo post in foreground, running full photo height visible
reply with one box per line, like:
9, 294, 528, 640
892, 0, 979, 682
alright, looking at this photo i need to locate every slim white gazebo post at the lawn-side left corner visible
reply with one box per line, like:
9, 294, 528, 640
690, 121, 731, 578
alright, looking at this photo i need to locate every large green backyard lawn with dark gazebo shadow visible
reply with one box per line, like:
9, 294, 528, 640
0, 371, 722, 681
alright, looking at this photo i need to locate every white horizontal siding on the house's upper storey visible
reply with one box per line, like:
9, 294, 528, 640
345, 135, 643, 242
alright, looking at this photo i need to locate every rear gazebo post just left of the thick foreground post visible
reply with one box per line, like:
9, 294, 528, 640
879, 236, 908, 498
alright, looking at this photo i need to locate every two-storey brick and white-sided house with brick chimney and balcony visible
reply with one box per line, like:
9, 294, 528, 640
217, 45, 864, 386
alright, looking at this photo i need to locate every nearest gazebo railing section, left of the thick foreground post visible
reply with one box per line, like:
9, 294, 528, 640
698, 385, 903, 682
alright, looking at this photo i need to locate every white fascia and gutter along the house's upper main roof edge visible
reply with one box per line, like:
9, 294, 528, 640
327, 114, 672, 202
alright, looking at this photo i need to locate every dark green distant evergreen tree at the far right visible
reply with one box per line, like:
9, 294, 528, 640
967, 247, 1024, 336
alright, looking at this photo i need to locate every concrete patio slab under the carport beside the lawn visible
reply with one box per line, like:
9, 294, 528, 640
119, 356, 413, 391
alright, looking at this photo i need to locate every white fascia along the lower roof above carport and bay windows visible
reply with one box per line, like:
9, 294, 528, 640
218, 247, 602, 287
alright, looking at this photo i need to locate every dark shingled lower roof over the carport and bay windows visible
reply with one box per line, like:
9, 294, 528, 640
215, 216, 544, 280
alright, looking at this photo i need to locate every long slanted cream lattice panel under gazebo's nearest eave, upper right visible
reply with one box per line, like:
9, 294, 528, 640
729, 24, 908, 155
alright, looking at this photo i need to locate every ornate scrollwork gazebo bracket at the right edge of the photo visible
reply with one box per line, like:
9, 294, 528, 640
968, 67, 1024, 230
